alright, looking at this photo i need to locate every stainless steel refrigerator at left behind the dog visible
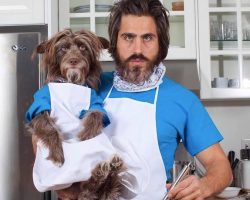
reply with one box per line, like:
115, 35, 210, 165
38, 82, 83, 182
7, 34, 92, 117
0, 25, 50, 200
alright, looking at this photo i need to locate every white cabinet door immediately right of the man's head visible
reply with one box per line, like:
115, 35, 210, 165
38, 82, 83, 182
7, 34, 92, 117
162, 0, 196, 60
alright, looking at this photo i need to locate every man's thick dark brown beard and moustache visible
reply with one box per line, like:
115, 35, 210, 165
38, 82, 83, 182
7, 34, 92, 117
115, 54, 156, 84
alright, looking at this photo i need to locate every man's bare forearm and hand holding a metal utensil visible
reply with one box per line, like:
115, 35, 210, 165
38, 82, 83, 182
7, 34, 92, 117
169, 143, 232, 200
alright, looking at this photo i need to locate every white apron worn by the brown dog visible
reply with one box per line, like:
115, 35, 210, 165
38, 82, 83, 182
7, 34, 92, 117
33, 83, 142, 199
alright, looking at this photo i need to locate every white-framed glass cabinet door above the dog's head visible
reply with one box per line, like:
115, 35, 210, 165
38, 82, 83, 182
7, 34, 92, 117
59, 0, 110, 38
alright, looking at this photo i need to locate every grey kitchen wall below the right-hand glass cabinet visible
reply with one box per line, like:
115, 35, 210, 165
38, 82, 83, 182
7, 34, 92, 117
204, 100, 250, 158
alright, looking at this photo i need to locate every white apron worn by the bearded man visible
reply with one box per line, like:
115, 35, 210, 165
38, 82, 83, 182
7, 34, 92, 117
104, 87, 167, 200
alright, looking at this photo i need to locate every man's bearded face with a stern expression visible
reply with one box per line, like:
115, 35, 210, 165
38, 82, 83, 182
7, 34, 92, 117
117, 15, 159, 83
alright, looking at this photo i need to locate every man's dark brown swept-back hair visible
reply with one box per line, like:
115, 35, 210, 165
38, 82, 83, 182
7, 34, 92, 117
108, 0, 169, 64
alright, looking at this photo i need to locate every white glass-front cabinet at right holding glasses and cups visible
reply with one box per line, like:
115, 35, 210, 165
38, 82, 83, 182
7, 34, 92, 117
197, 0, 250, 99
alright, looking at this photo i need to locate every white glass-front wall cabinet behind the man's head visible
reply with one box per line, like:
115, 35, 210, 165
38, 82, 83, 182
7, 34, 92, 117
59, 0, 196, 61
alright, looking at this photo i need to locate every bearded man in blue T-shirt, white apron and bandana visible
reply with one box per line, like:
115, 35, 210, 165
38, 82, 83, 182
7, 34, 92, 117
56, 0, 232, 200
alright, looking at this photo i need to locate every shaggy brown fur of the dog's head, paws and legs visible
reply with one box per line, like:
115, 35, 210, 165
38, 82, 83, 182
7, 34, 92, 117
27, 29, 126, 200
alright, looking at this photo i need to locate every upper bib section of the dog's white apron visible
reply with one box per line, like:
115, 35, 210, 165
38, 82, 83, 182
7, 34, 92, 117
48, 83, 91, 142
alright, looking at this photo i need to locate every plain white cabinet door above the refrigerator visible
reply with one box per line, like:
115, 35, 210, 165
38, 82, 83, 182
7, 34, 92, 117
0, 0, 45, 25
